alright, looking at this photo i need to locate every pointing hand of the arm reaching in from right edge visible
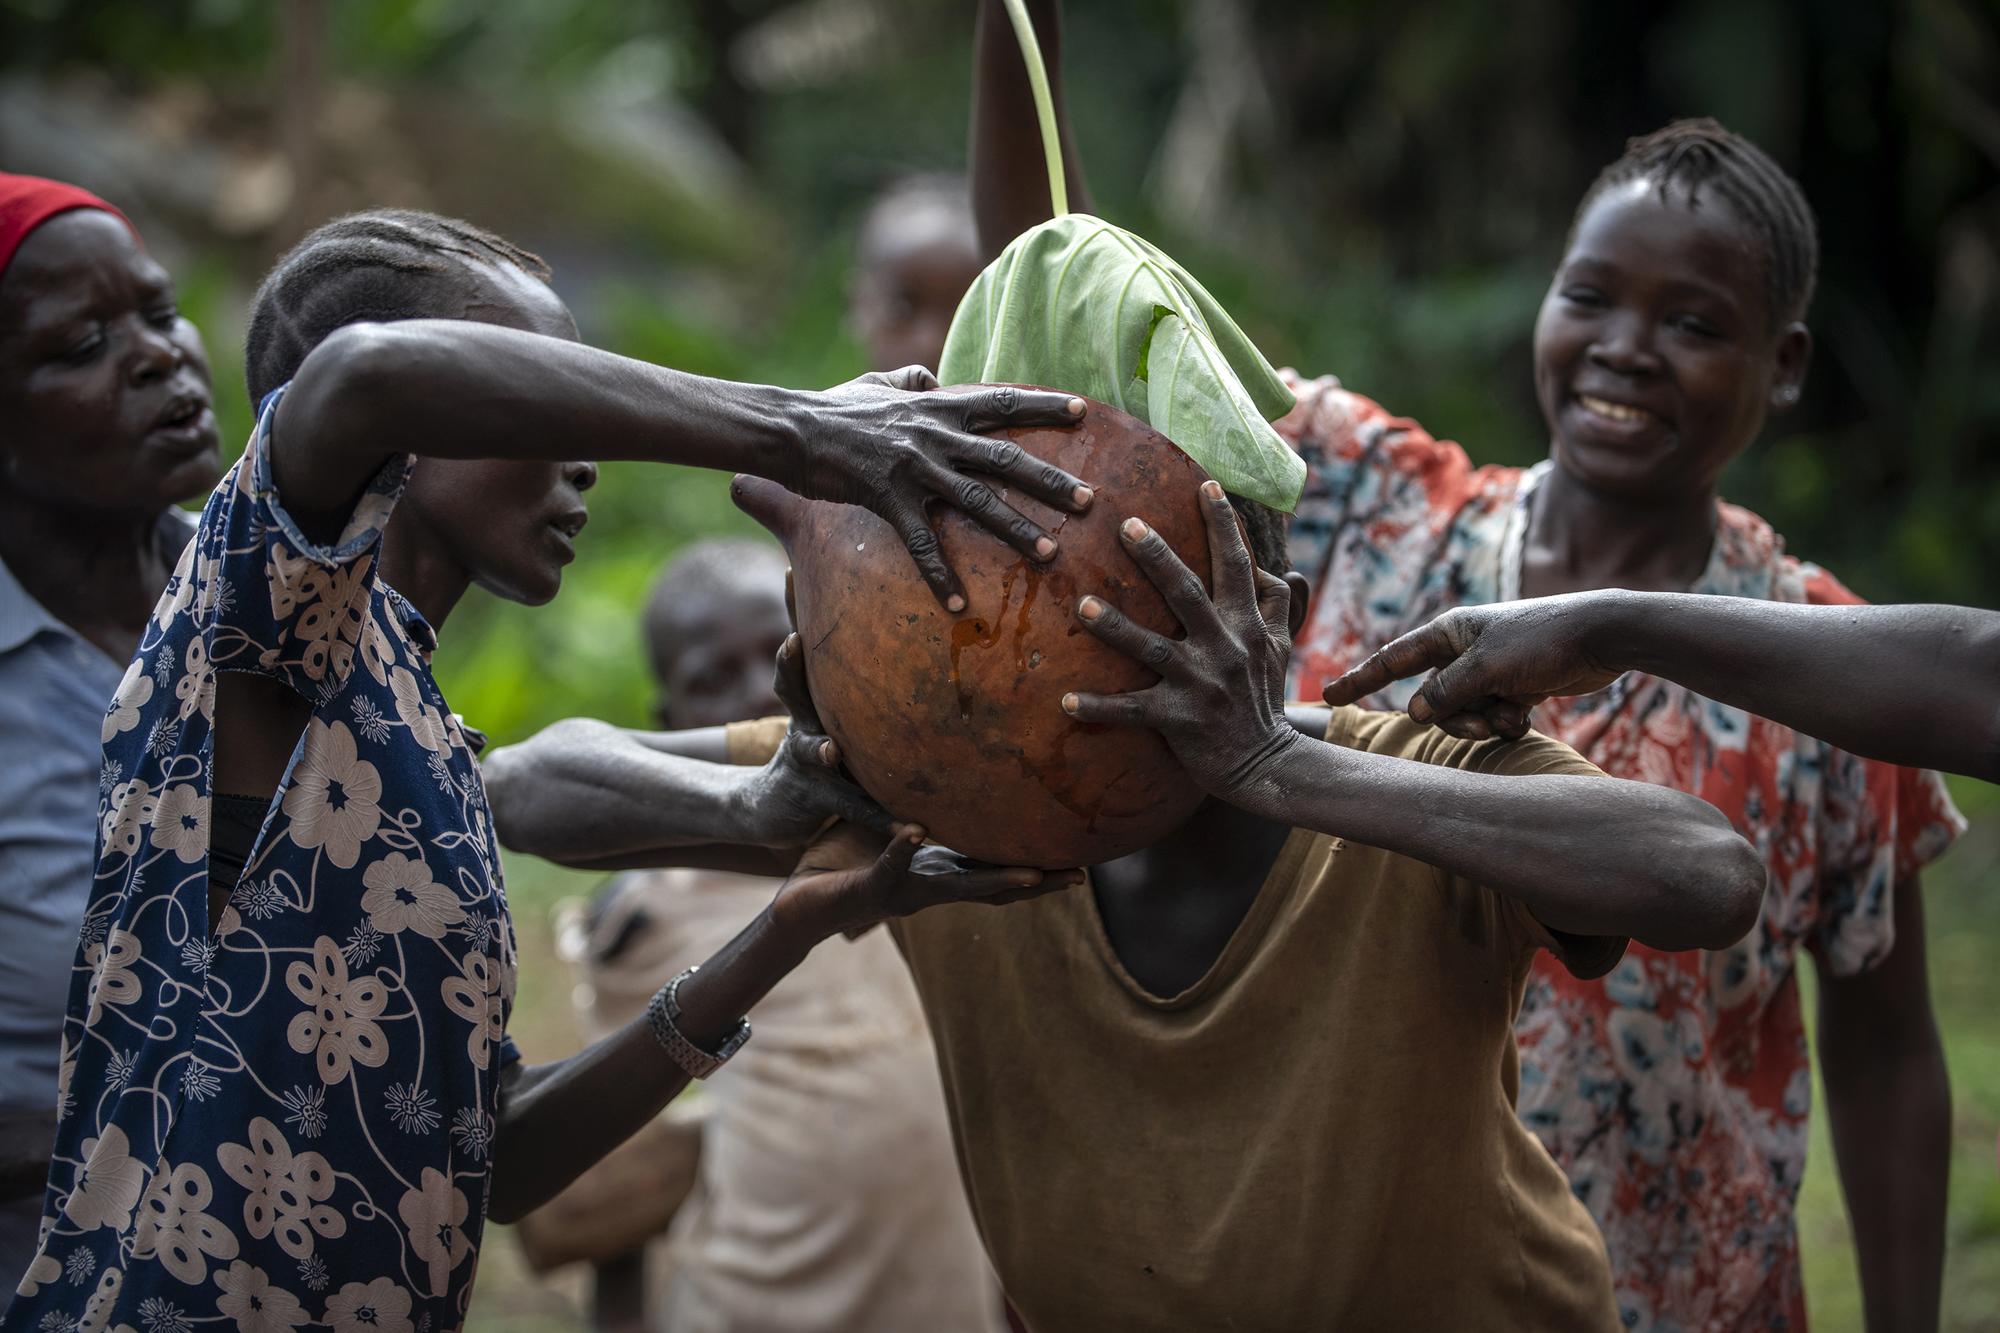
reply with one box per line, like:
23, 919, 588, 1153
1326, 592, 1620, 741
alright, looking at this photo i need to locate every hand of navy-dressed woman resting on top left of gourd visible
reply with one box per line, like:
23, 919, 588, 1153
792, 366, 1090, 612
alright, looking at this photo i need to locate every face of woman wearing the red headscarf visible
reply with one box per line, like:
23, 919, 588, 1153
0, 208, 222, 518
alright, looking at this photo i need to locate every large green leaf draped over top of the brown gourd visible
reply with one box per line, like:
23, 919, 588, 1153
938, 212, 1306, 512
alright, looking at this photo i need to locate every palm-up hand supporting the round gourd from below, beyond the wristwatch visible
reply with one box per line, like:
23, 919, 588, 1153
772, 823, 1084, 939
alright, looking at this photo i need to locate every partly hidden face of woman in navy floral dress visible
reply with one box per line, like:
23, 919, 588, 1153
390, 264, 598, 606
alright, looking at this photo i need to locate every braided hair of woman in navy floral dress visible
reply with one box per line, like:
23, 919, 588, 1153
244, 208, 550, 402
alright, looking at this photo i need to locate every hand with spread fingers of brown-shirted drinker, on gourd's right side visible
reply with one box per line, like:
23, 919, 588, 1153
1062, 480, 1298, 801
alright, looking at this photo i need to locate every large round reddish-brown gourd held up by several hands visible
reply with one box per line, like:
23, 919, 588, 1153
734, 386, 1208, 867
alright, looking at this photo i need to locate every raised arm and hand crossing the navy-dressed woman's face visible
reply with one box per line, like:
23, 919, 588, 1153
272, 320, 1090, 608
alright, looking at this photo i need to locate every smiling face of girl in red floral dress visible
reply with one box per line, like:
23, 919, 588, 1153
1534, 178, 1812, 502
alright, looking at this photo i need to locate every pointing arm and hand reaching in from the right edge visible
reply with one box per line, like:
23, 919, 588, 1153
1326, 590, 2000, 783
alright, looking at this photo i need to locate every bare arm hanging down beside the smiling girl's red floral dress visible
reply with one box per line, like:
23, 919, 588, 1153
1818, 877, 1952, 1333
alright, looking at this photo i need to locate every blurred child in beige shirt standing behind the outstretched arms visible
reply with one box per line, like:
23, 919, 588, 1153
524, 540, 1002, 1333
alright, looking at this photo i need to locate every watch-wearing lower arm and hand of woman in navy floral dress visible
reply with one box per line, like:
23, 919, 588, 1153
492, 825, 1080, 1223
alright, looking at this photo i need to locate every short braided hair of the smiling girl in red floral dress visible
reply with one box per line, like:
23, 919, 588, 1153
1570, 116, 1820, 328
